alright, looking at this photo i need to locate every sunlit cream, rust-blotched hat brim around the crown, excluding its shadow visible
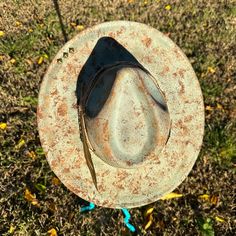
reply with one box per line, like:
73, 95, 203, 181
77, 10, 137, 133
37, 21, 204, 208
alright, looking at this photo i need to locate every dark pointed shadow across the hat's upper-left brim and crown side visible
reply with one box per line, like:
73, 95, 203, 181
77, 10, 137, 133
76, 37, 143, 118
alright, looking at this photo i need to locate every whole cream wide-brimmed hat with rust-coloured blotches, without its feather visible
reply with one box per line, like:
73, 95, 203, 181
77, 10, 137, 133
37, 21, 204, 208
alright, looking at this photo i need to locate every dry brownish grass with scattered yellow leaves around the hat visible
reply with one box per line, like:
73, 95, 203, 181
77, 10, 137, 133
0, 0, 236, 236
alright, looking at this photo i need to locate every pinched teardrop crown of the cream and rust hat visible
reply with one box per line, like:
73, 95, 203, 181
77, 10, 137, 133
85, 63, 170, 168
